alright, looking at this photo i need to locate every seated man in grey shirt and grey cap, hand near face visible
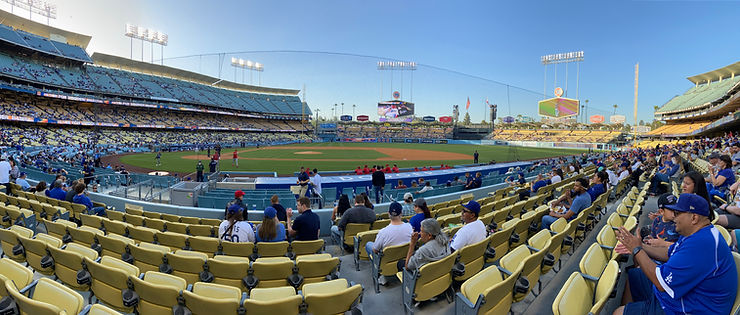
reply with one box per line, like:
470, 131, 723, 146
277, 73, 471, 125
397, 219, 450, 271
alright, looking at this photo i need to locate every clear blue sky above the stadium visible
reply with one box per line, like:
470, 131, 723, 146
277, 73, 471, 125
7, 0, 740, 123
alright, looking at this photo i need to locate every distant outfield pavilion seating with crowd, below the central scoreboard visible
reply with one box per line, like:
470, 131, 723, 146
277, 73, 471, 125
337, 122, 452, 139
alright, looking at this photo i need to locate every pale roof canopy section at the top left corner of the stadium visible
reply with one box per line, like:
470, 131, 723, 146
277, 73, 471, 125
0, 10, 92, 49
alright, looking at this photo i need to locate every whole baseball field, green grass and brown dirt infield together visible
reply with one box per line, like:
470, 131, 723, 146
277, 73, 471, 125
117, 143, 584, 175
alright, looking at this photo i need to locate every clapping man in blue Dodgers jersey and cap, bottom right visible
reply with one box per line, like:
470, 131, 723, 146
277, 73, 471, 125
614, 194, 737, 314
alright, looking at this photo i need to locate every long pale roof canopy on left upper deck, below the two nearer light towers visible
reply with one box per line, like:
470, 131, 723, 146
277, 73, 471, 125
92, 52, 300, 96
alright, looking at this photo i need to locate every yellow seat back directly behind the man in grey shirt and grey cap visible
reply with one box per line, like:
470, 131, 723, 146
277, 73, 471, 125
404, 254, 457, 301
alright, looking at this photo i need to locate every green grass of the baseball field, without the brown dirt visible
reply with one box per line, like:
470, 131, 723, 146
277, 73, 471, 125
121, 143, 585, 175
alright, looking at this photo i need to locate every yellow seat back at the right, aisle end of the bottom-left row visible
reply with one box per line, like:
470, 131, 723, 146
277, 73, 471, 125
303, 279, 362, 314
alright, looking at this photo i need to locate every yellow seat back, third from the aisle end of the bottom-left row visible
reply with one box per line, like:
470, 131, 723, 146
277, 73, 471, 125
182, 282, 241, 315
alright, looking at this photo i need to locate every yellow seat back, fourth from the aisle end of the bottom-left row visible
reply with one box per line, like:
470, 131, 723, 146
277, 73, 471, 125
129, 271, 187, 315
